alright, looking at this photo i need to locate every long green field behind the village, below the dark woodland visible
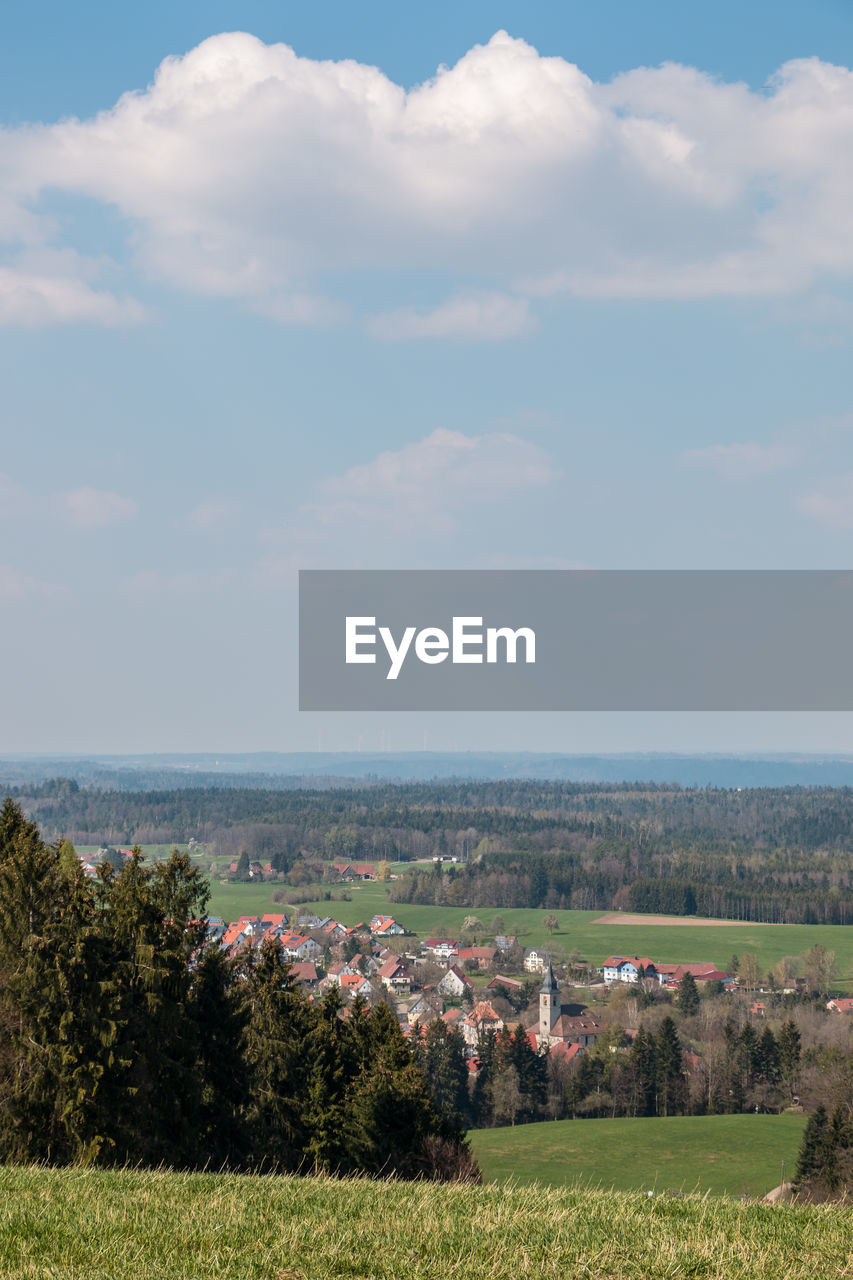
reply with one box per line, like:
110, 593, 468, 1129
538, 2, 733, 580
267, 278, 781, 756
204, 882, 853, 977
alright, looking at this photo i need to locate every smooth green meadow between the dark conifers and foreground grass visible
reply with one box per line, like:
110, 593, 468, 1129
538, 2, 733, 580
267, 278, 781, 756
470, 1115, 806, 1196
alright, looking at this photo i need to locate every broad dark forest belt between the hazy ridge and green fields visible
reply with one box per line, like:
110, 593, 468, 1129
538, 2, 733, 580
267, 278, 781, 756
9, 780, 853, 924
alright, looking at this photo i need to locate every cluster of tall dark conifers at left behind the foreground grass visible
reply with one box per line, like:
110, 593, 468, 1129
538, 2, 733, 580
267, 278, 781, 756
0, 800, 476, 1178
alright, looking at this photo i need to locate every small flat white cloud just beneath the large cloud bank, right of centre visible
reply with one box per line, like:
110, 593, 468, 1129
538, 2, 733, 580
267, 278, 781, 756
368, 293, 537, 342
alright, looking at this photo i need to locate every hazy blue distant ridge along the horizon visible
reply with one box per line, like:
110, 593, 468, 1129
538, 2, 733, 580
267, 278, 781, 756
0, 751, 853, 790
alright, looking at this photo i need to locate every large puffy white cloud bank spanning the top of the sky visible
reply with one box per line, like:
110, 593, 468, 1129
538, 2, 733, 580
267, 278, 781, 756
0, 32, 853, 320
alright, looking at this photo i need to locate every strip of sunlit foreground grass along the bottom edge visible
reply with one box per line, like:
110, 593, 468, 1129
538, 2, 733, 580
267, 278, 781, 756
0, 1169, 853, 1280
